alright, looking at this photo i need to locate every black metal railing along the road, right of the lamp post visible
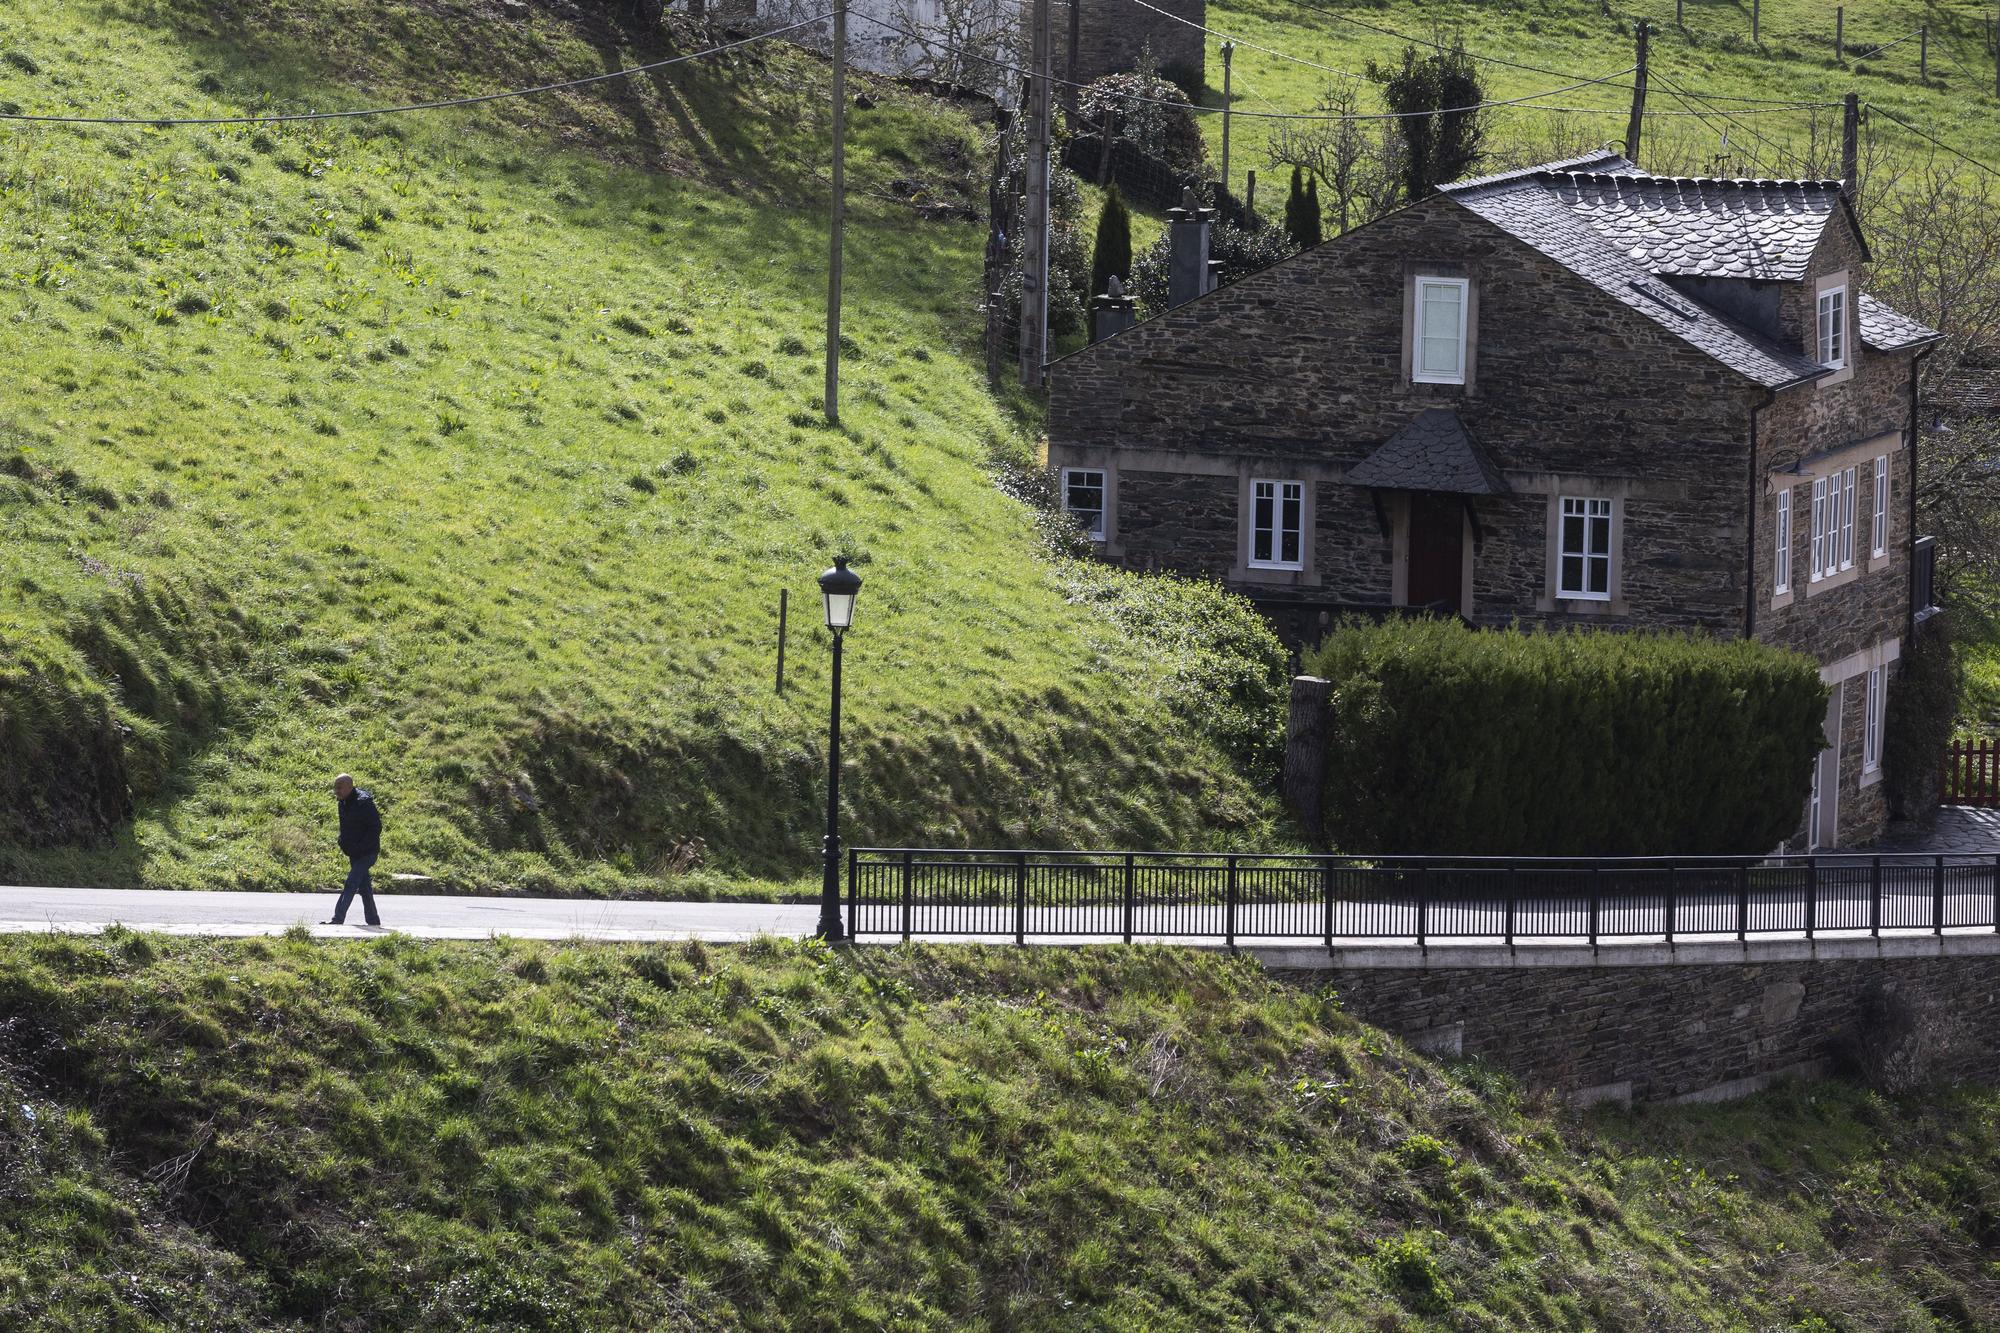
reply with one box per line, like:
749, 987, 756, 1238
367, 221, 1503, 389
848, 847, 2000, 945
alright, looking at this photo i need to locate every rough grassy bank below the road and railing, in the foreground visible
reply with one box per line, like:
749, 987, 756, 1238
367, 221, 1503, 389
0, 935, 2000, 1333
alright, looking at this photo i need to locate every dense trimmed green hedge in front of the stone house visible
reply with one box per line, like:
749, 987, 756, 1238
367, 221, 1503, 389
1304, 620, 1826, 857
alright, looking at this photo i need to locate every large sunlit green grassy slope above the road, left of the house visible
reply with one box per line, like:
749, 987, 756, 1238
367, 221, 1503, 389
0, 0, 1262, 893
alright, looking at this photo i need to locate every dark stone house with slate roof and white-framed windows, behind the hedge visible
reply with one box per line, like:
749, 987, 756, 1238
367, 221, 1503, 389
1048, 152, 1938, 847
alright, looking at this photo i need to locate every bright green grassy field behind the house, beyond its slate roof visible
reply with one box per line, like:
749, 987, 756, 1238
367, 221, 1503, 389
1202, 0, 2000, 197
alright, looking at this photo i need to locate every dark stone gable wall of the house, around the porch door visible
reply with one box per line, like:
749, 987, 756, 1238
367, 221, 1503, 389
1048, 196, 1762, 632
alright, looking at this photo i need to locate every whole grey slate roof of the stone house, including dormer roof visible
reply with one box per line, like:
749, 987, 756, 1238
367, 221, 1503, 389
1444, 152, 1938, 388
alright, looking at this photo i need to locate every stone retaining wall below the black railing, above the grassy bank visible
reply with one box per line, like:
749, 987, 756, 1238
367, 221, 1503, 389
1288, 944, 2000, 1101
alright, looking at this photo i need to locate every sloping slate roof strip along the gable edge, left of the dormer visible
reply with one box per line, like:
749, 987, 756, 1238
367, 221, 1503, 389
1444, 158, 1824, 388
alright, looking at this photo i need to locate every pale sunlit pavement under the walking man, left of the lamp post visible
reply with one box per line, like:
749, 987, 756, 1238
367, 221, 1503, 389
0, 887, 820, 943
